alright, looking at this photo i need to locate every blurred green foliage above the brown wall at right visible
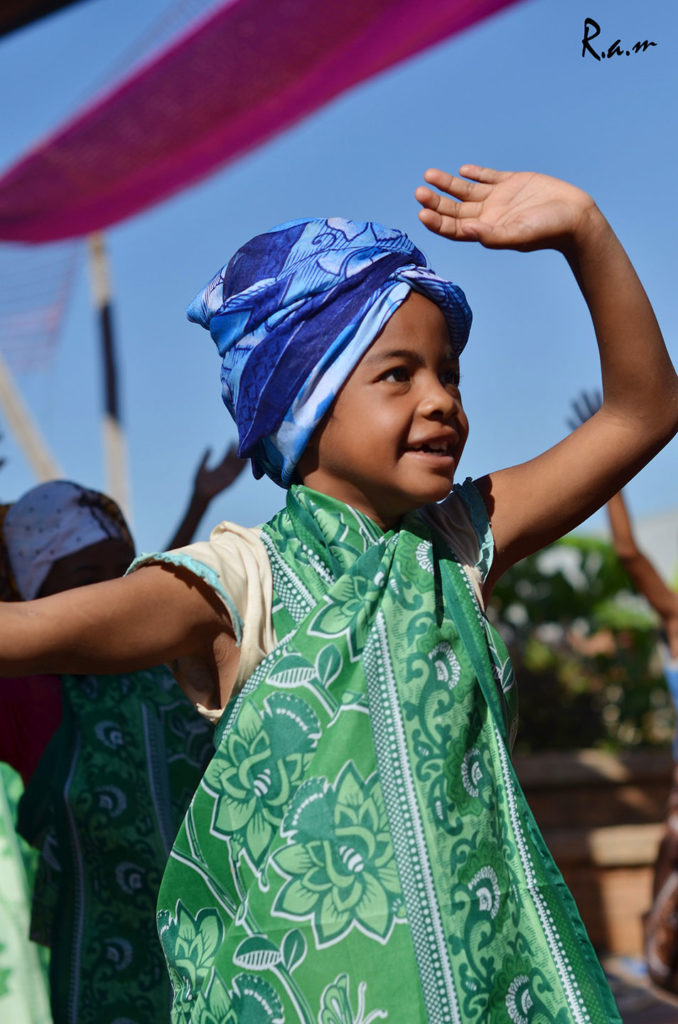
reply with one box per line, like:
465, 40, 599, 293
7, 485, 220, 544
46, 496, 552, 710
489, 537, 674, 753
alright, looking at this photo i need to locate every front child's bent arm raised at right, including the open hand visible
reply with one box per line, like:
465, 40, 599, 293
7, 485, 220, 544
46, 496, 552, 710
415, 164, 678, 593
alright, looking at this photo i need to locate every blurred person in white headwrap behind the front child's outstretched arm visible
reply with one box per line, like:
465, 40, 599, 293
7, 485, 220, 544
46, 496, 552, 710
0, 449, 244, 1024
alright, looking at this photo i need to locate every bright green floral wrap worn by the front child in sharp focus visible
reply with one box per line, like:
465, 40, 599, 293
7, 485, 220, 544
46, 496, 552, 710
159, 484, 620, 1024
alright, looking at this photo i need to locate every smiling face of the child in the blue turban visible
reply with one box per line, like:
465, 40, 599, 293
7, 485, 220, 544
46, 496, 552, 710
297, 292, 468, 529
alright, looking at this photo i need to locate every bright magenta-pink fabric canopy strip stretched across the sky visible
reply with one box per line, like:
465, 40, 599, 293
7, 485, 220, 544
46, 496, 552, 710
0, 0, 516, 243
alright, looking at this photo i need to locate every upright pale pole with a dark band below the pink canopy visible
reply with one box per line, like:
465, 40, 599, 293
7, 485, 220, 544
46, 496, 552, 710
88, 231, 130, 521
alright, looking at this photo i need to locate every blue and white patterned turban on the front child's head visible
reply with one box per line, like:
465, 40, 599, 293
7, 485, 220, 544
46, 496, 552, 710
186, 217, 471, 487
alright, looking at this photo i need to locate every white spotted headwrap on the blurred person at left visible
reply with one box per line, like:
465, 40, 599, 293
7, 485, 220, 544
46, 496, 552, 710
2, 480, 134, 601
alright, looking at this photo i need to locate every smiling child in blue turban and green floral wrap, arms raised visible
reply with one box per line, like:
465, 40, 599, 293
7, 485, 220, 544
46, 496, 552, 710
0, 165, 678, 1024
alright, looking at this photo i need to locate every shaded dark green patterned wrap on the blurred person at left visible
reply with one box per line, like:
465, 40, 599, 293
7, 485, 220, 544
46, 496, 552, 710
18, 666, 213, 1024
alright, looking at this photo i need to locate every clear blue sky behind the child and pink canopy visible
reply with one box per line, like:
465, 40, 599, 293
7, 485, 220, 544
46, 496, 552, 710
0, 0, 678, 559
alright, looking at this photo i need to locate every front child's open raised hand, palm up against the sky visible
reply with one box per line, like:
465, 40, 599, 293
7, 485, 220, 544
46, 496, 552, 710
415, 164, 602, 252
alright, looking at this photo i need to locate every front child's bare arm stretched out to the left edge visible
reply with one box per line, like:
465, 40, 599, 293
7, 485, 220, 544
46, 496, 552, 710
0, 565, 238, 702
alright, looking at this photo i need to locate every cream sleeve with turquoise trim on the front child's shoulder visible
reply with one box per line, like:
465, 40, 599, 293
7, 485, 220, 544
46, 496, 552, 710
128, 522, 276, 693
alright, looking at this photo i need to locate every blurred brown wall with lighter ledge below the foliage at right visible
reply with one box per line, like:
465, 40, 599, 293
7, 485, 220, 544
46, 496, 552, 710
514, 751, 673, 956
